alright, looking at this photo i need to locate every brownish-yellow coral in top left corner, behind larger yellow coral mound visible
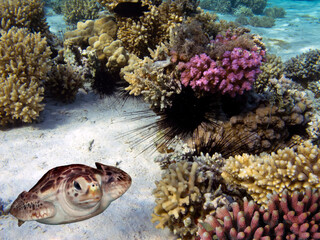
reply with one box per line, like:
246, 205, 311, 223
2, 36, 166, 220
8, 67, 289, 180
0, 0, 49, 34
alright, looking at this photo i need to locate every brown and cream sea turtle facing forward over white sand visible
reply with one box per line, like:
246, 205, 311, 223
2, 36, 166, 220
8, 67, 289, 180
10, 163, 131, 226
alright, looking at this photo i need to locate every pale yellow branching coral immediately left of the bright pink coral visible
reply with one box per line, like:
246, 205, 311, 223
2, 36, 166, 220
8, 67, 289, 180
121, 44, 181, 111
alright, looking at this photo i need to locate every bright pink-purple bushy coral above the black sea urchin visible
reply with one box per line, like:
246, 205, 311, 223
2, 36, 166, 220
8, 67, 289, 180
178, 48, 264, 97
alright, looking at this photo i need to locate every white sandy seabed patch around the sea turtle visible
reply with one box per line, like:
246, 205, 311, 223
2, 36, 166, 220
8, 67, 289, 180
0, 93, 174, 240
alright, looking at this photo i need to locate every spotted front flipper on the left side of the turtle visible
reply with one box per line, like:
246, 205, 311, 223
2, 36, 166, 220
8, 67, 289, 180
10, 192, 56, 222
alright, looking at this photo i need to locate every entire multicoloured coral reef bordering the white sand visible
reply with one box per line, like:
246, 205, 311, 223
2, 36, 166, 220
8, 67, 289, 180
0, 0, 320, 240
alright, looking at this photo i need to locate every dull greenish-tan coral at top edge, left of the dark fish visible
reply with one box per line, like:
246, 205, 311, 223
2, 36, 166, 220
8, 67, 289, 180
62, 0, 101, 24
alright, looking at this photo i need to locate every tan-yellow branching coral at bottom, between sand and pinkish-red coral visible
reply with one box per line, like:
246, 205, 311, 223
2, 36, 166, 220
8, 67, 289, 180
151, 162, 202, 235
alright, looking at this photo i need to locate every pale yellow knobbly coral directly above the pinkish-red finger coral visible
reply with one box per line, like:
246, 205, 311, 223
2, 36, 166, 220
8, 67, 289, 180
221, 141, 320, 205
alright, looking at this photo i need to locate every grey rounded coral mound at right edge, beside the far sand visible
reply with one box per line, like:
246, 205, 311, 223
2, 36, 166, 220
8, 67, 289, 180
284, 49, 320, 84
